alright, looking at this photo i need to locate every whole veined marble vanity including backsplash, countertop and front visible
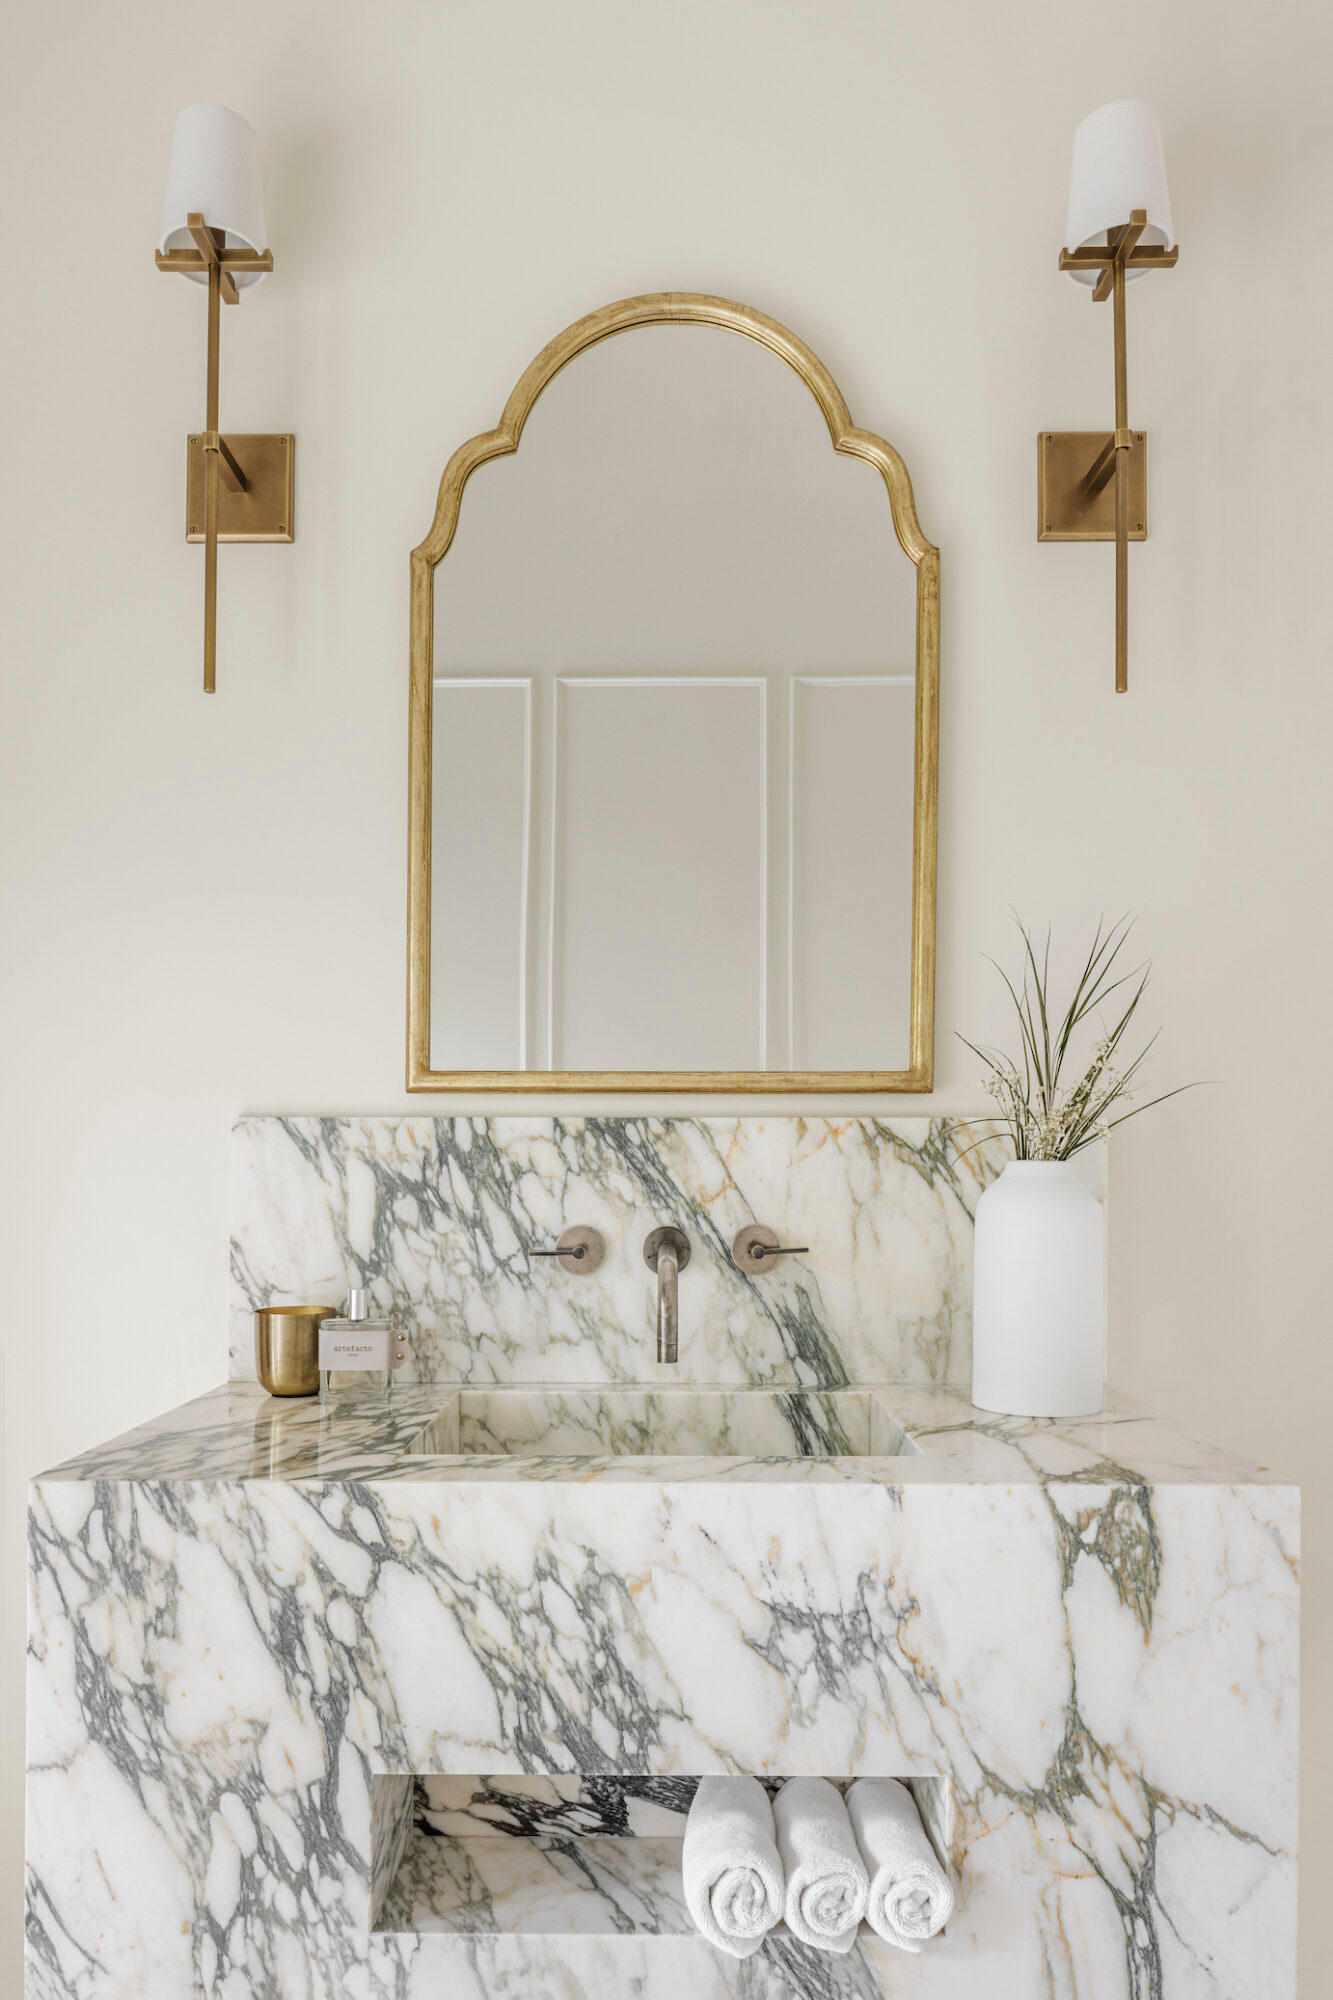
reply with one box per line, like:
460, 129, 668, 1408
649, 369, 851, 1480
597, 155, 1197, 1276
26, 1118, 1299, 2000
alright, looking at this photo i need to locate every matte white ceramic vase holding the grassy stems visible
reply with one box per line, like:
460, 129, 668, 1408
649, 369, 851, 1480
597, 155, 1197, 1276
973, 1160, 1107, 1416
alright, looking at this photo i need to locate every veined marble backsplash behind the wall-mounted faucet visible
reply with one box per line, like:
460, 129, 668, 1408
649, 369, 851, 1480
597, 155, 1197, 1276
230, 1116, 1105, 1388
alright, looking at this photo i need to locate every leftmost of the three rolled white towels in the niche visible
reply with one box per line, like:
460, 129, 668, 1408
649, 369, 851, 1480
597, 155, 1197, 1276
681, 1778, 783, 1958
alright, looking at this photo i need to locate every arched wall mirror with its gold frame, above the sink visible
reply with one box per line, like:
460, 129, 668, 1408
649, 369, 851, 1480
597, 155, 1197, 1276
406, 292, 939, 1092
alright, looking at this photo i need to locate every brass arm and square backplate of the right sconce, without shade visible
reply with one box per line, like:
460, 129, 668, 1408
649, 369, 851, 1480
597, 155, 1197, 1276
1037, 208, 1181, 694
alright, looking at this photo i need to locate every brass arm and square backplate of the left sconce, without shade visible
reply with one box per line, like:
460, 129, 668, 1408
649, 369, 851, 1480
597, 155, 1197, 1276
156, 210, 296, 694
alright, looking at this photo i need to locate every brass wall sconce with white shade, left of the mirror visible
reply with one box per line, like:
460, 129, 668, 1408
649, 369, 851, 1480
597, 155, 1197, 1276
156, 104, 296, 694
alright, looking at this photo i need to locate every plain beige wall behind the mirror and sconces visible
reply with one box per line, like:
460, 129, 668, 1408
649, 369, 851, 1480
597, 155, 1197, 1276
0, 0, 1333, 1994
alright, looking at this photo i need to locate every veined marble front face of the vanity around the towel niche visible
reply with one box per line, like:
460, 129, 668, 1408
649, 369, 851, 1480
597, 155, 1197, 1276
28, 1478, 1297, 2000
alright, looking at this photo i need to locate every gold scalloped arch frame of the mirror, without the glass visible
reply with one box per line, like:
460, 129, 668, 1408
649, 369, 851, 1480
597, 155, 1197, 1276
406, 292, 939, 1096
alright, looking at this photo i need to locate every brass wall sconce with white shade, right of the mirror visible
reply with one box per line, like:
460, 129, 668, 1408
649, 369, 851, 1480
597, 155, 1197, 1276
1037, 98, 1179, 694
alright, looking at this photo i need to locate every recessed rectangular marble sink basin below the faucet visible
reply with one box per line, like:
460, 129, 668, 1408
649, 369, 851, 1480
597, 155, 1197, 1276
408, 1388, 913, 1458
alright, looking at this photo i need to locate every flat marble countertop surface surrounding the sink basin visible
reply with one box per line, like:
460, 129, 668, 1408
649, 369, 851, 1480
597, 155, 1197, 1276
38, 1382, 1295, 1488
